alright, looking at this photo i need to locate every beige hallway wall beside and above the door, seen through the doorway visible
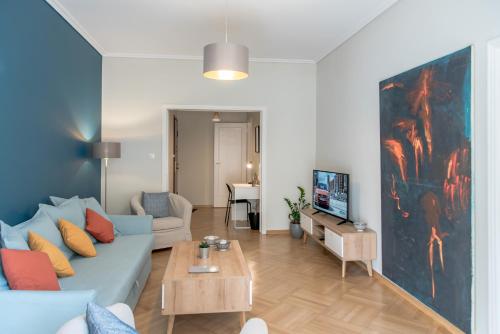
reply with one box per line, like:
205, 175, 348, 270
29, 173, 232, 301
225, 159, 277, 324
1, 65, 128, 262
175, 111, 247, 205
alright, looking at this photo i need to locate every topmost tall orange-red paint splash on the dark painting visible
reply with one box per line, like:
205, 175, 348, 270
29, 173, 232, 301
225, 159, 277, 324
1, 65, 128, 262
410, 69, 433, 160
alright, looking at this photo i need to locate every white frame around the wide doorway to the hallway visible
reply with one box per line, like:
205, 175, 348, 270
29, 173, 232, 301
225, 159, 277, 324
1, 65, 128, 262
160, 104, 267, 234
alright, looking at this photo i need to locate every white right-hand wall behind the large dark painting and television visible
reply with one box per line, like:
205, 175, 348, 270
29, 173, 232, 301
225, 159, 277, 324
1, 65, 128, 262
316, 0, 500, 333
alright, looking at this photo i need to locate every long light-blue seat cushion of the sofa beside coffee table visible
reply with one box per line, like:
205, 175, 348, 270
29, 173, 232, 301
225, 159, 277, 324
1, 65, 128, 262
59, 234, 153, 306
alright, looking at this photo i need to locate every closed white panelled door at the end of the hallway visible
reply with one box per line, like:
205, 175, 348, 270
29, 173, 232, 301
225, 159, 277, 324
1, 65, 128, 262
214, 123, 247, 207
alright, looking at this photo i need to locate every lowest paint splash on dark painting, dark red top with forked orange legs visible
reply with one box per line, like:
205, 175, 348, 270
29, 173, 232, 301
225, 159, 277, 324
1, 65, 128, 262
421, 192, 448, 299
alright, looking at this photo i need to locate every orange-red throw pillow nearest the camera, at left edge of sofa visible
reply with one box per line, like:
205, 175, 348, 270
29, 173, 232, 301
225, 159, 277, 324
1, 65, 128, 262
0, 248, 61, 291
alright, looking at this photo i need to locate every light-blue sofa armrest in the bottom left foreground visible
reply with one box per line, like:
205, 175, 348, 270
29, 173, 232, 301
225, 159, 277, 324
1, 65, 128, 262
0, 290, 96, 334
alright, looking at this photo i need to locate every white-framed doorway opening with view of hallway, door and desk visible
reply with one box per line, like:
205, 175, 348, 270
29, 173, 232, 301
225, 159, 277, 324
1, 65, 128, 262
162, 106, 266, 233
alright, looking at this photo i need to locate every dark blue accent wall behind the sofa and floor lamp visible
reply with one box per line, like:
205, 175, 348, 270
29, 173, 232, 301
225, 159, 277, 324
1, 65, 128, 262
0, 0, 102, 225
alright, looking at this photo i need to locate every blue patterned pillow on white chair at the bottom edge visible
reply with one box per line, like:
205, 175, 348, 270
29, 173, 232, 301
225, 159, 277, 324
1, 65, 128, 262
86, 303, 138, 334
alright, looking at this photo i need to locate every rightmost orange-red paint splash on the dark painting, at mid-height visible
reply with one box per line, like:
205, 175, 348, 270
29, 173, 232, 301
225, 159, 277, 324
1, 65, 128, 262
443, 148, 471, 220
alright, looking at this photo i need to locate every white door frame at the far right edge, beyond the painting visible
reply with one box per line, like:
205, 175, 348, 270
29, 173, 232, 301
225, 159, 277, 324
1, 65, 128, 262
487, 38, 500, 334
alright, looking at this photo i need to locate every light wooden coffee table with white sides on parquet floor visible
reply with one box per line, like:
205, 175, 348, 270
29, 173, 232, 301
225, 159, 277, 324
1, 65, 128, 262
161, 240, 252, 334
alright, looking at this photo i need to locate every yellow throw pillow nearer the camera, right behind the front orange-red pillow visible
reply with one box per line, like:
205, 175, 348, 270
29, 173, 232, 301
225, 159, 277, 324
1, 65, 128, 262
28, 231, 75, 277
